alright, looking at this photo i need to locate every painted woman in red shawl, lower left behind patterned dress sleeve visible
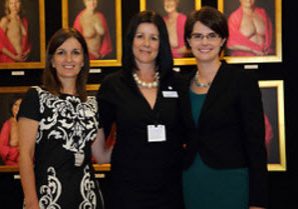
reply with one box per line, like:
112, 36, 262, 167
0, 97, 22, 166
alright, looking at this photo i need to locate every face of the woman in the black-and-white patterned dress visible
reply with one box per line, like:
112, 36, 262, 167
52, 37, 84, 82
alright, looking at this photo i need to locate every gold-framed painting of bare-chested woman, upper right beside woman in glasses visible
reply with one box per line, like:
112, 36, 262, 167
217, 0, 282, 63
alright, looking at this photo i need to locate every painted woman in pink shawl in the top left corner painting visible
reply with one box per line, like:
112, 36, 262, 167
0, 0, 31, 63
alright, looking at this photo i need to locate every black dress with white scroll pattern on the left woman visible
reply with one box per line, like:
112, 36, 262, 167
18, 87, 103, 209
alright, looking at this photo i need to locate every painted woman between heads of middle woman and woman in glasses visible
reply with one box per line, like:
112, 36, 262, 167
163, 0, 187, 58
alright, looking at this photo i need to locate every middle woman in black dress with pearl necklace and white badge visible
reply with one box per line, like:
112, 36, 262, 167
98, 11, 185, 209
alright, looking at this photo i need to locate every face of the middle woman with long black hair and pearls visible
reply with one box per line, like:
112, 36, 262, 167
132, 23, 160, 65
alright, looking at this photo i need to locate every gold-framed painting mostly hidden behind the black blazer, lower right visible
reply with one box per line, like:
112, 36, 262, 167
259, 80, 286, 171
